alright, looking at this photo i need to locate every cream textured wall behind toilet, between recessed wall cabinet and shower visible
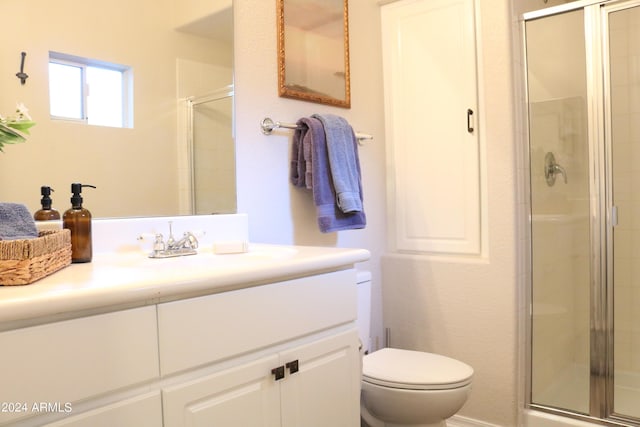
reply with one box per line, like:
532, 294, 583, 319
382, 1, 520, 426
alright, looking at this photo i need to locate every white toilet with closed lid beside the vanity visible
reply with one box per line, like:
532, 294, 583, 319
357, 271, 473, 427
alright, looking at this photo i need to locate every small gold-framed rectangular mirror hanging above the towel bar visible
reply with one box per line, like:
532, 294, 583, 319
277, 0, 351, 108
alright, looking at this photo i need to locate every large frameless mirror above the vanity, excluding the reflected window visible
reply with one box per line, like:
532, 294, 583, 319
0, 0, 236, 218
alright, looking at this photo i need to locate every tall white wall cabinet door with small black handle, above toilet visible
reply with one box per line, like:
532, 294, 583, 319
381, 0, 481, 254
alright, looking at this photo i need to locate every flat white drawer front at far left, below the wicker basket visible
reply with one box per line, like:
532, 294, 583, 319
0, 306, 159, 425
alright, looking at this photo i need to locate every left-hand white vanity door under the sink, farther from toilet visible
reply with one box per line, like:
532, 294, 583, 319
162, 355, 280, 427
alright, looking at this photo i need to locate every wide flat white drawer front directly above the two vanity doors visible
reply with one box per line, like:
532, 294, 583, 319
158, 269, 357, 375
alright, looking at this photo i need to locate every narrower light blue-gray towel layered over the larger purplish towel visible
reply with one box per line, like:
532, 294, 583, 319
312, 114, 362, 213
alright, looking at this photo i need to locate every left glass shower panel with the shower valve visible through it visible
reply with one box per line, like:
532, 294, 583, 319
525, 10, 591, 414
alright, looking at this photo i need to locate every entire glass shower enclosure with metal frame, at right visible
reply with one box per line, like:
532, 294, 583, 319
523, 0, 640, 426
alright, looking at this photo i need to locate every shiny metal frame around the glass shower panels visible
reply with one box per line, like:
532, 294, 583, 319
520, 0, 640, 426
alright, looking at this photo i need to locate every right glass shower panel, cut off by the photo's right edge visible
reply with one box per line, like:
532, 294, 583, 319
604, 2, 640, 418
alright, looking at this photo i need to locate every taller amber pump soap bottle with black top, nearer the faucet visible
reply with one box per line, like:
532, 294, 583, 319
62, 183, 96, 263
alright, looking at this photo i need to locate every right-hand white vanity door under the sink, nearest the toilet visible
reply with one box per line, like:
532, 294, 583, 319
279, 329, 360, 427
